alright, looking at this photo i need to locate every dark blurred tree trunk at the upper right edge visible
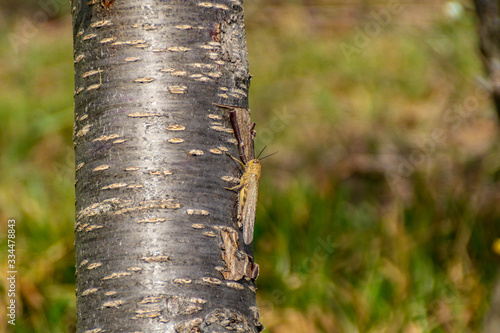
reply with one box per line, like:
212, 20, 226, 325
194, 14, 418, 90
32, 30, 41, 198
474, 0, 500, 117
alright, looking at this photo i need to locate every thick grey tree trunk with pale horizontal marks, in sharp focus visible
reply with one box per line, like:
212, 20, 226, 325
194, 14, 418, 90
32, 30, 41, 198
72, 0, 263, 332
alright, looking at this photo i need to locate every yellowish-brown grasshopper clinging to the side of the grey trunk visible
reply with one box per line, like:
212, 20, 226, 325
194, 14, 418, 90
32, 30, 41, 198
226, 153, 261, 245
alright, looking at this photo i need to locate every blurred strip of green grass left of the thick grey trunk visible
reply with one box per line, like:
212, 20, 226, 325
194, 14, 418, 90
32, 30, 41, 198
0, 12, 76, 332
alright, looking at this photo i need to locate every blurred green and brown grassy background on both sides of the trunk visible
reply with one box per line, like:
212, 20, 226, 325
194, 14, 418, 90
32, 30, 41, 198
0, 0, 500, 333
